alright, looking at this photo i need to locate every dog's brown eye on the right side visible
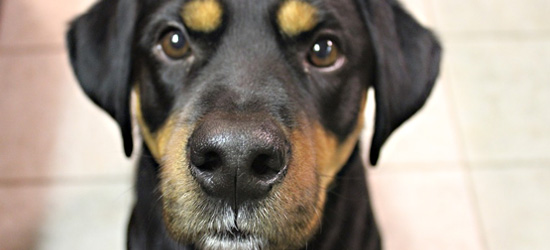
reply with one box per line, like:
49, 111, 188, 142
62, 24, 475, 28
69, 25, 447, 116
308, 39, 340, 67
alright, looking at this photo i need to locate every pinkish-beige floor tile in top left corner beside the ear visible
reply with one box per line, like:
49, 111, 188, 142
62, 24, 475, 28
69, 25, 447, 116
0, 0, 94, 47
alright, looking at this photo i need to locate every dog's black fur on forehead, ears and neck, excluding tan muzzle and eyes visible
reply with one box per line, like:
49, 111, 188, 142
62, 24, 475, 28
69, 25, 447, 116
67, 0, 441, 250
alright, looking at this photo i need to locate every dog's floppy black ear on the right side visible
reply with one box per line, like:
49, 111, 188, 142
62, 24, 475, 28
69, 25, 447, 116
357, 0, 441, 165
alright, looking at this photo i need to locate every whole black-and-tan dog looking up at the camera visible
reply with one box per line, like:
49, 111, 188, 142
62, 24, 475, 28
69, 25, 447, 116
67, 0, 441, 250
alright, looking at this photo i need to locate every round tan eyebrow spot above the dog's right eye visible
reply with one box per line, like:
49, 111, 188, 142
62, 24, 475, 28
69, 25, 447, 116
277, 0, 319, 36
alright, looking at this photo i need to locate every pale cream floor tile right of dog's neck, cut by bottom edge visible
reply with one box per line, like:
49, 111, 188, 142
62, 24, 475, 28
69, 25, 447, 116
369, 169, 484, 250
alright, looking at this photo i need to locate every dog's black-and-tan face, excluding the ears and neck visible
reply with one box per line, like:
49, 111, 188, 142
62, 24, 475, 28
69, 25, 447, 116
133, 0, 373, 246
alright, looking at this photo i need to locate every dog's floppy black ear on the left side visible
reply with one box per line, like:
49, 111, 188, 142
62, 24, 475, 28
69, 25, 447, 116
66, 0, 137, 156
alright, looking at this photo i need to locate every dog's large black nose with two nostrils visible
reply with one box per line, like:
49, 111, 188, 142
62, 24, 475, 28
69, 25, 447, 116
188, 117, 289, 209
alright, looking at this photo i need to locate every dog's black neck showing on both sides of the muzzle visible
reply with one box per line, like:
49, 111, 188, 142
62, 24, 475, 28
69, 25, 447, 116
128, 144, 380, 250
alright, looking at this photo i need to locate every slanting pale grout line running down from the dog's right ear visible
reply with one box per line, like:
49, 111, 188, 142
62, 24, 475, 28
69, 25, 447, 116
444, 65, 490, 250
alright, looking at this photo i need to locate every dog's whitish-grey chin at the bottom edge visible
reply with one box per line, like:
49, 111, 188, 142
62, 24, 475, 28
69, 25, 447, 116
196, 230, 267, 250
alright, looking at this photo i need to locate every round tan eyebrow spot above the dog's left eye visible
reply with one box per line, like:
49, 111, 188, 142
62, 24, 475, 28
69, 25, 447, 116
181, 0, 223, 33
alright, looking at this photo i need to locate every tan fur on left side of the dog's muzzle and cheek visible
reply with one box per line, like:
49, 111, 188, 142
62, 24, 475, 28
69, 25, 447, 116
132, 88, 197, 240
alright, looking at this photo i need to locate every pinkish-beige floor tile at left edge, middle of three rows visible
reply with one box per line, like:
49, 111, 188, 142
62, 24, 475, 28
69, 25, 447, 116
0, 53, 63, 177
